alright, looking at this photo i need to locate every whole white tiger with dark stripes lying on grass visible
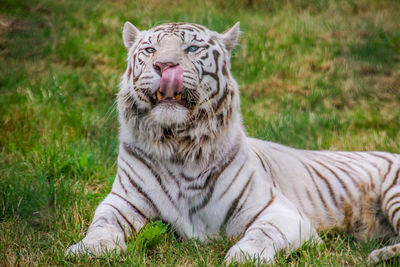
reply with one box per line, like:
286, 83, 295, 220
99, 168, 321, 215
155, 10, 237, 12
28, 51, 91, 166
67, 22, 400, 263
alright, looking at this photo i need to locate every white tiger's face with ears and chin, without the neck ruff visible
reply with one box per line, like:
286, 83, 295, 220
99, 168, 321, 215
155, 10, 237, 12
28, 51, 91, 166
123, 22, 237, 126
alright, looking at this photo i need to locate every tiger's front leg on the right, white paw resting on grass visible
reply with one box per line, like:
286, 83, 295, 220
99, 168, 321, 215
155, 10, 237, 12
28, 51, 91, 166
225, 197, 320, 264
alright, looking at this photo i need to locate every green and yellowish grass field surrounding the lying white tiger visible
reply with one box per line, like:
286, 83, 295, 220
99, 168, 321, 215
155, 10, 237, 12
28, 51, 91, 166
0, 0, 400, 266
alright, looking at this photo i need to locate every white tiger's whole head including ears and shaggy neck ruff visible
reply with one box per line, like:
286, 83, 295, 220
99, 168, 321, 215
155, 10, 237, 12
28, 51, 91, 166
118, 22, 240, 164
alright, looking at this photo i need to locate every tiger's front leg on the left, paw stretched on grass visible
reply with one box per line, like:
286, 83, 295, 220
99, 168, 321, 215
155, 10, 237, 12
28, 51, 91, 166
66, 193, 147, 255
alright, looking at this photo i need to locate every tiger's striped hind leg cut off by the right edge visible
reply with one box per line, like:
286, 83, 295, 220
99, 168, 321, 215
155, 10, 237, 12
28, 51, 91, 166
368, 160, 400, 263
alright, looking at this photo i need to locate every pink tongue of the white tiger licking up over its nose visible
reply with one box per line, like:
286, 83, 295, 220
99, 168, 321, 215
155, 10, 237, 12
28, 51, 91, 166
160, 66, 183, 97
